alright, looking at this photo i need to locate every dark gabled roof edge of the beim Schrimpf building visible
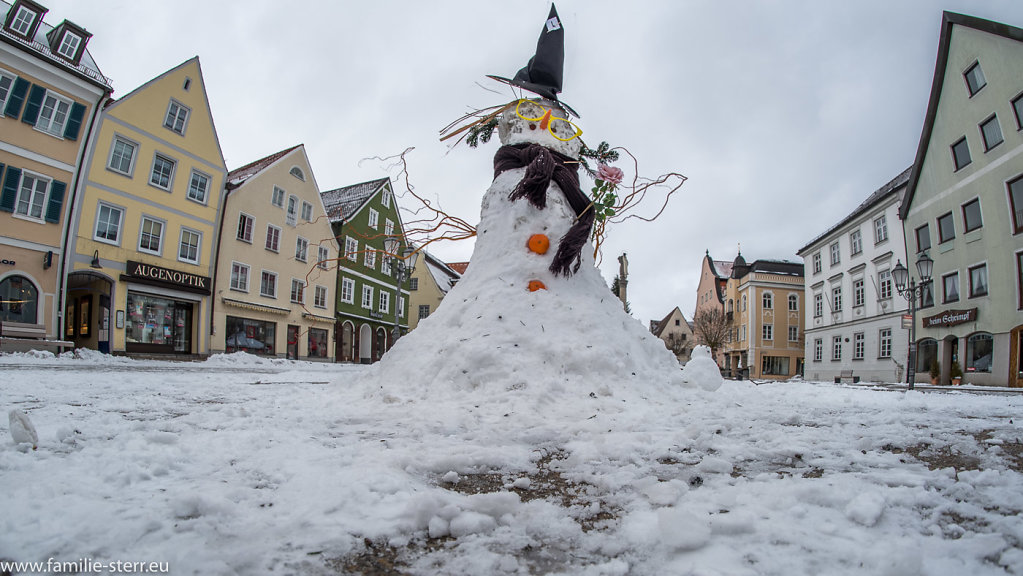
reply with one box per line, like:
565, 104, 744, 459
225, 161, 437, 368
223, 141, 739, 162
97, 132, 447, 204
898, 11, 1023, 220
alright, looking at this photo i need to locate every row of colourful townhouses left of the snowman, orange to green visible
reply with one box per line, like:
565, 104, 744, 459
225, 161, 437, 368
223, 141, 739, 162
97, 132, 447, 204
0, 0, 457, 362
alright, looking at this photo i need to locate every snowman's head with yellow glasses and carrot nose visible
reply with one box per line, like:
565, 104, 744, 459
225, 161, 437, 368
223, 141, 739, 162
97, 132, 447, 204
497, 98, 582, 158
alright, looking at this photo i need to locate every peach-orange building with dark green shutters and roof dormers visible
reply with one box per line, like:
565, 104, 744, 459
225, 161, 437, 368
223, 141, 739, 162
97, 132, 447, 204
0, 0, 110, 351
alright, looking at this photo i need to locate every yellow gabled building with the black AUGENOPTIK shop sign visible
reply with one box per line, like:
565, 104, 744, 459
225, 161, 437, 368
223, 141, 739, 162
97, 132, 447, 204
63, 57, 227, 356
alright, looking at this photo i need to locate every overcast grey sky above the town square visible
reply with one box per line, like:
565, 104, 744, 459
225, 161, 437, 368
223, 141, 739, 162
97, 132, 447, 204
43, 0, 1023, 323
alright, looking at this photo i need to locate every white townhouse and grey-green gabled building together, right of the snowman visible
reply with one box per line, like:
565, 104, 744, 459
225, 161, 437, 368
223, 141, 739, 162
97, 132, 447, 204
799, 12, 1023, 387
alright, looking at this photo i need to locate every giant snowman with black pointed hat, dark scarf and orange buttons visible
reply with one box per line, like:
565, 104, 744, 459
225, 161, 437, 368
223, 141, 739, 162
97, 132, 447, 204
374, 6, 681, 394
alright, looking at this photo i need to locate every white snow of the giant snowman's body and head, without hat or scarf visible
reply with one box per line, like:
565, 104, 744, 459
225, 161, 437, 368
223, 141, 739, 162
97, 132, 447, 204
364, 101, 681, 392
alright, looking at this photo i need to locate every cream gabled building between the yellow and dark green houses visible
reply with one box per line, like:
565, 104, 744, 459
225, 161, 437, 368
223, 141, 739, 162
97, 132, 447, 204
213, 144, 338, 362
